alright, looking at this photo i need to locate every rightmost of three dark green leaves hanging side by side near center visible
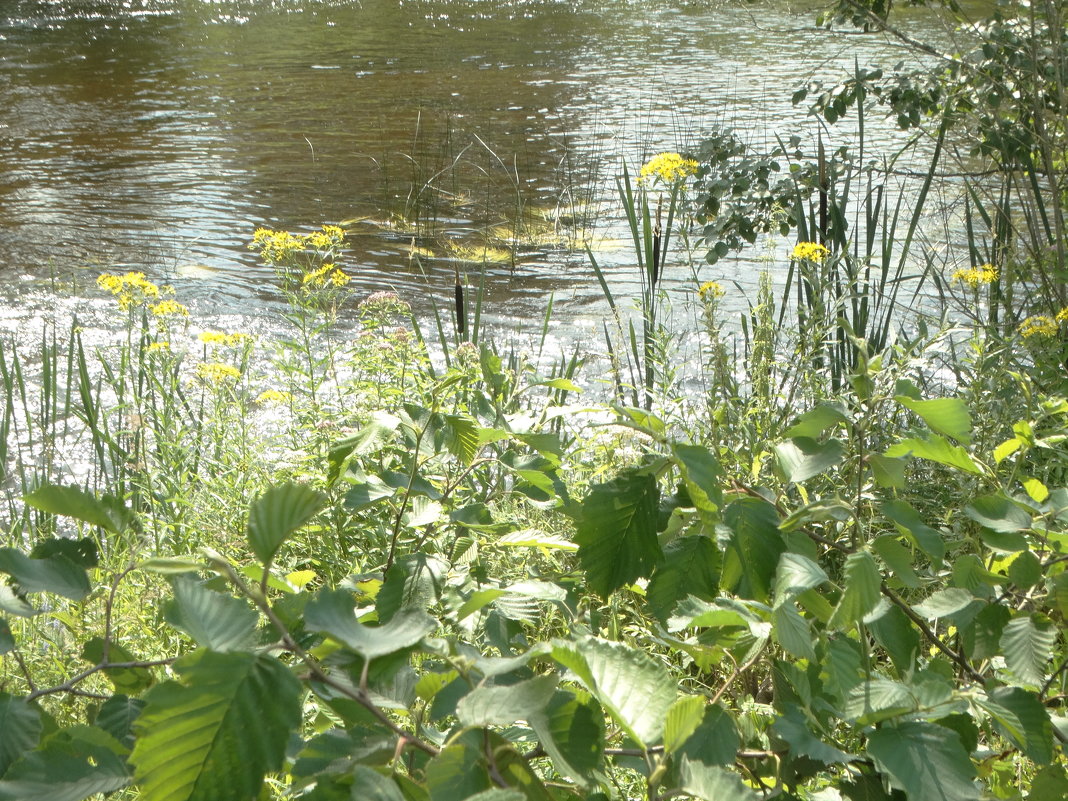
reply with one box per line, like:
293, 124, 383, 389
720, 498, 786, 602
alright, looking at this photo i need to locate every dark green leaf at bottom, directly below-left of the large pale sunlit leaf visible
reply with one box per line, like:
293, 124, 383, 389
528, 689, 604, 785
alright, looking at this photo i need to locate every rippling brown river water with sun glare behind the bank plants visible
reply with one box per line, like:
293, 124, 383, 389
0, 0, 944, 346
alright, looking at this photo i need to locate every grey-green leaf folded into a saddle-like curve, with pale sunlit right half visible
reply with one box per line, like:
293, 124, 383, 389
304, 590, 438, 659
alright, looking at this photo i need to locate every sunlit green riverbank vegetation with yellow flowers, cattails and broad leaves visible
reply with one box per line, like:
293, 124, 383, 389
0, 0, 1068, 801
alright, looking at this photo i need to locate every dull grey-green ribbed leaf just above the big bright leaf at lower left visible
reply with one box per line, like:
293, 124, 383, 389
163, 575, 260, 651
